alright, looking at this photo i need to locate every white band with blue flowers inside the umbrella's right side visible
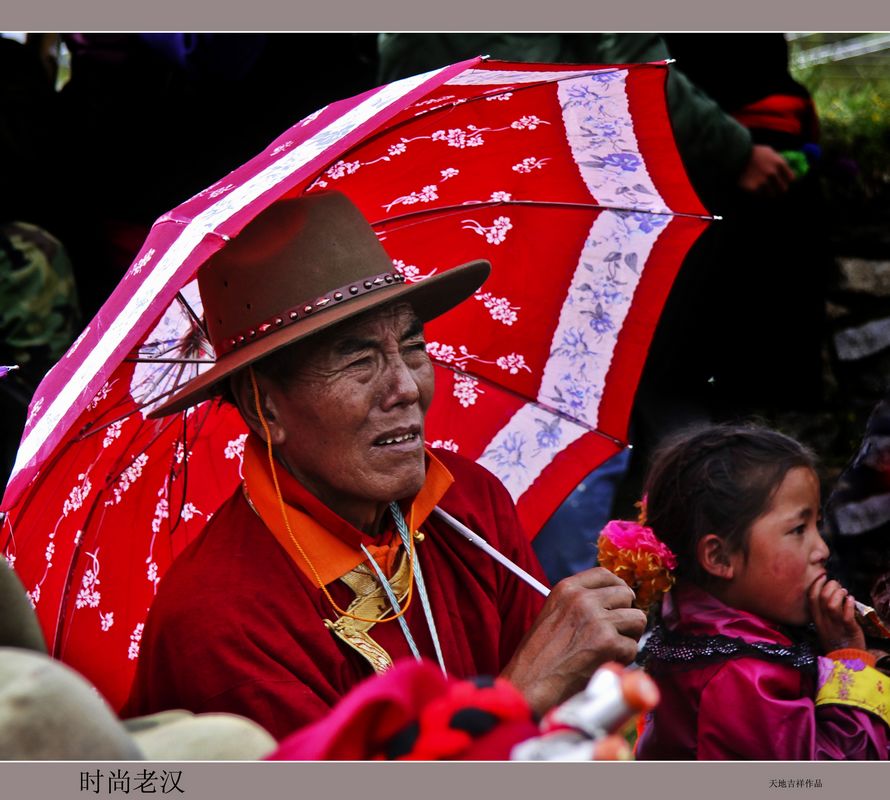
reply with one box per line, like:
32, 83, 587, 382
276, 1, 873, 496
478, 71, 669, 500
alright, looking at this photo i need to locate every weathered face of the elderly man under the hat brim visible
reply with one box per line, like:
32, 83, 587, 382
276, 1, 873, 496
264, 303, 433, 530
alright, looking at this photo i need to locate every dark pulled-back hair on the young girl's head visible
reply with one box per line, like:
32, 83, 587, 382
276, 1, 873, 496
644, 425, 816, 583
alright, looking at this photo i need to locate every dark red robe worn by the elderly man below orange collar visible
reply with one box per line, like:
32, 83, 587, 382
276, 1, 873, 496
124, 450, 546, 739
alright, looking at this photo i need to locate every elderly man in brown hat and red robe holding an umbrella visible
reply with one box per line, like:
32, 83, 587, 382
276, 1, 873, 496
125, 192, 645, 738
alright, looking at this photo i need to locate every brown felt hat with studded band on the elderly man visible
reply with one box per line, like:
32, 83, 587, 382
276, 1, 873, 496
150, 192, 491, 417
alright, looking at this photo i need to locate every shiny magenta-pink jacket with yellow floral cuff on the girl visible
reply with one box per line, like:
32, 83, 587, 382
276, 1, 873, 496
636, 586, 890, 761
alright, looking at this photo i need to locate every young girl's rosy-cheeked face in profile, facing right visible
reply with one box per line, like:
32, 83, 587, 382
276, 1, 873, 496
724, 467, 828, 625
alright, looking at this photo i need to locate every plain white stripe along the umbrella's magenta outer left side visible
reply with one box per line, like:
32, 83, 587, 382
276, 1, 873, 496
10, 70, 444, 494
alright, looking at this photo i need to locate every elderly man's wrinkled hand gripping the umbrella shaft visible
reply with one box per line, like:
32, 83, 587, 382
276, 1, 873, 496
502, 567, 646, 714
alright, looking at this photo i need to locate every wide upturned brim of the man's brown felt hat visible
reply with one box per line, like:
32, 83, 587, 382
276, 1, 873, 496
148, 260, 491, 419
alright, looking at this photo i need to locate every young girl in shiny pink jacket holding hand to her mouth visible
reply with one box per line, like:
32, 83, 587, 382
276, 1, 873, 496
624, 426, 890, 760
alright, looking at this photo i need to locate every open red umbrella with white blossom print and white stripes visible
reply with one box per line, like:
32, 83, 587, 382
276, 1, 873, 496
0, 59, 709, 705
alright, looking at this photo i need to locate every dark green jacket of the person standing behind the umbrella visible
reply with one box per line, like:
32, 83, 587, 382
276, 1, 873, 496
378, 33, 752, 205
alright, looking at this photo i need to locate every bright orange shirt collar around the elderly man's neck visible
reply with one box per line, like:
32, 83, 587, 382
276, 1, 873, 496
243, 434, 454, 585
